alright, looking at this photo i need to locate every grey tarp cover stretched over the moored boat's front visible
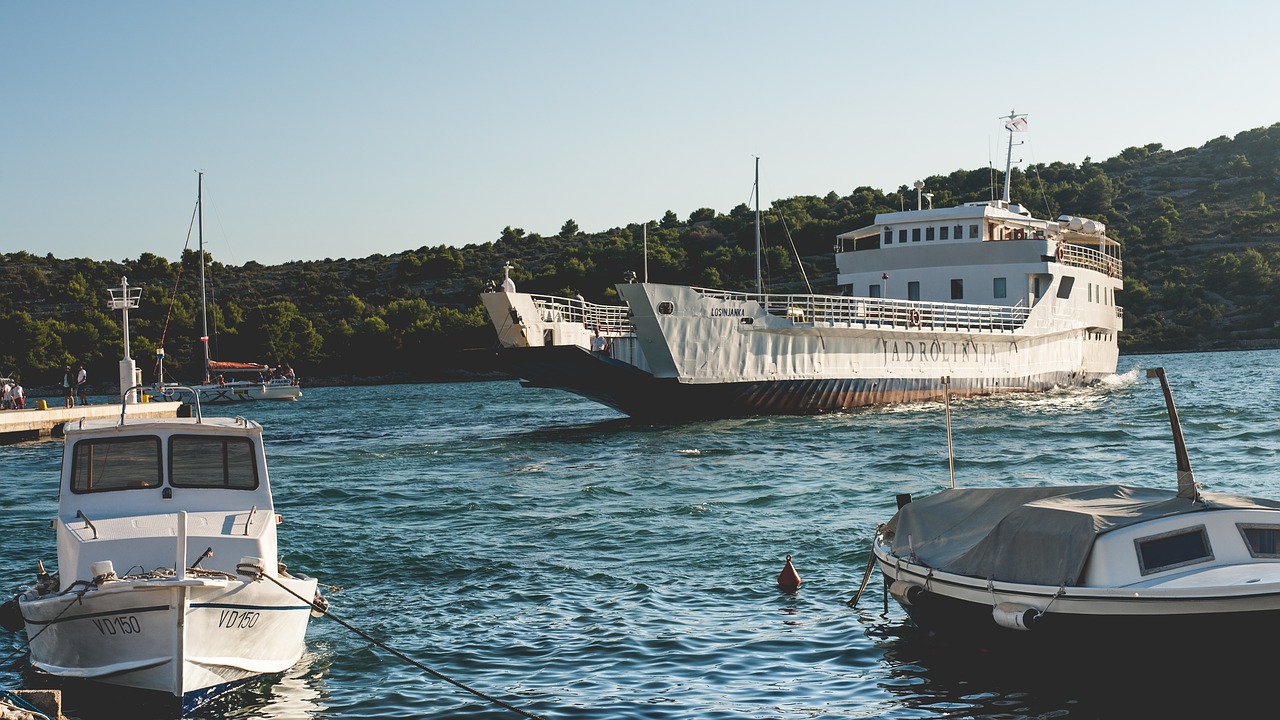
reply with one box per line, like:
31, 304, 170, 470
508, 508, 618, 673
886, 486, 1280, 587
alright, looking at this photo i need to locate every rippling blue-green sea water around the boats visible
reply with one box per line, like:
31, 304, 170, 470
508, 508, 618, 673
0, 351, 1280, 720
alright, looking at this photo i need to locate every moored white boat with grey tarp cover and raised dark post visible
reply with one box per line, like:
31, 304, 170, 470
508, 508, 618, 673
870, 369, 1280, 656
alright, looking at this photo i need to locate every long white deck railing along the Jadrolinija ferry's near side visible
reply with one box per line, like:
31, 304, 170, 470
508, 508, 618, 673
694, 287, 1030, 332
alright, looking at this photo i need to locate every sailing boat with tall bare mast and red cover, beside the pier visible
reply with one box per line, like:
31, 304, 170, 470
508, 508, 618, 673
155, 173, 302, 405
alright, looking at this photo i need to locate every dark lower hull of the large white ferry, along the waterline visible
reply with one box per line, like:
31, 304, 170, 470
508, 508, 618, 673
497, 346, 1105, 419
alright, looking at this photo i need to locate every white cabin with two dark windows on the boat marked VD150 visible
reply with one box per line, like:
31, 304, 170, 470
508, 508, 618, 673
55, 416, 278, 589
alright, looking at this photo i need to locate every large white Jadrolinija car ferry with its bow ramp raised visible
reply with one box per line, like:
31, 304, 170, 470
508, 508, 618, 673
481, 117, 1123, 418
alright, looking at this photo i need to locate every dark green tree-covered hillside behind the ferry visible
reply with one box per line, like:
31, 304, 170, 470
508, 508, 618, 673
0, 124, 1280, 387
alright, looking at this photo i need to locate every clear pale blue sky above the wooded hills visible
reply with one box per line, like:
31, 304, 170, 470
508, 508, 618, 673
0, 0, 1280, 265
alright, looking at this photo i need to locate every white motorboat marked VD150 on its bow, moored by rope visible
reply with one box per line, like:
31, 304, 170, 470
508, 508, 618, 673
4, 388, 325, 715
